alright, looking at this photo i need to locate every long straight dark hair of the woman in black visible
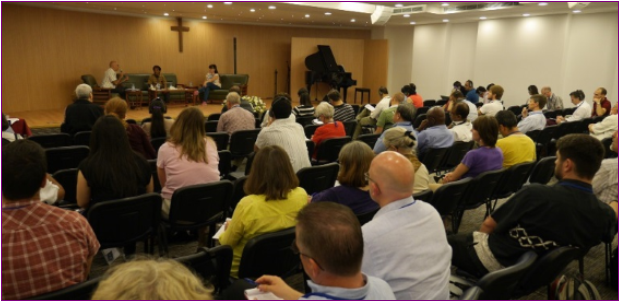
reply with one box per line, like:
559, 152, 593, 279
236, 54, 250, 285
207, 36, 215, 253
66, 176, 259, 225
86, 115, 139, 198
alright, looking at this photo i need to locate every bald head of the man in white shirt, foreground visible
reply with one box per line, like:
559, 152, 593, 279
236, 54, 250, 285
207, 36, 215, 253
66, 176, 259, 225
368, 151, 415, 206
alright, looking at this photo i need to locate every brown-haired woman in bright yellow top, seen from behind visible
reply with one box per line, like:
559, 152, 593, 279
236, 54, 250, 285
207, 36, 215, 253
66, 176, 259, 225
220, 146, 308, 278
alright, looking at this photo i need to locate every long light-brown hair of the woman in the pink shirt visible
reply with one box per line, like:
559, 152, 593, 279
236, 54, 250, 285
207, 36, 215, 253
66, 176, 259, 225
170, 107, 209, 164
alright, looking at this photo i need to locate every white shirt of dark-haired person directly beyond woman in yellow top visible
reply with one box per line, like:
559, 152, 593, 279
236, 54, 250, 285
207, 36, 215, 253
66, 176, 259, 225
256, 118, 311, 172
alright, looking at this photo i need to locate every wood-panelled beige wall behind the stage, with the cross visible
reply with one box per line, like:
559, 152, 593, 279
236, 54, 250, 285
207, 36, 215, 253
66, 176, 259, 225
2, 4, 370, 112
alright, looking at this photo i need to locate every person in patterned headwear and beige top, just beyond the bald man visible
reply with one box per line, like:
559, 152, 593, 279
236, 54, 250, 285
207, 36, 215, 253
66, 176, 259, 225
383, 127, 431, 194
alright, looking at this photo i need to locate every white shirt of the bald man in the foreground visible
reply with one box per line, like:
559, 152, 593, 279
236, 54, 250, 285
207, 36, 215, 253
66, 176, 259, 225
362, 197, 452, 300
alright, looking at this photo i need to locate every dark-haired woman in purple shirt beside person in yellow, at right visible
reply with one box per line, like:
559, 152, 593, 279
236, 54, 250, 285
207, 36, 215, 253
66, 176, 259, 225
443, 116, 504, 184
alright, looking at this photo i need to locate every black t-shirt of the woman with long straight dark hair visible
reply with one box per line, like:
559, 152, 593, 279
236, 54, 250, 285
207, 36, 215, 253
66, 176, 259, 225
79, 153, 151, 208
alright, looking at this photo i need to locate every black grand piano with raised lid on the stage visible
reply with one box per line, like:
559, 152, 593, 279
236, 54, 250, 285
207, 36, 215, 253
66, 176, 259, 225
306, 45, 357, 103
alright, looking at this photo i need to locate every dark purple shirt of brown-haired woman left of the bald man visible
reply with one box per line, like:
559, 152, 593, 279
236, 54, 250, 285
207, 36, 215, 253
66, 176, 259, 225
312, 186, 379, 215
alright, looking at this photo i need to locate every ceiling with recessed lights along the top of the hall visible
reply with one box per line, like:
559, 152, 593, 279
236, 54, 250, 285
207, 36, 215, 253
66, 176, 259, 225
10, 2, 618, 29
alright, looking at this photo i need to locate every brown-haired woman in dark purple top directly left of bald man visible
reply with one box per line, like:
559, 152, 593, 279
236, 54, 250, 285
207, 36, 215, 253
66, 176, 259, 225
311, 141, 379, 215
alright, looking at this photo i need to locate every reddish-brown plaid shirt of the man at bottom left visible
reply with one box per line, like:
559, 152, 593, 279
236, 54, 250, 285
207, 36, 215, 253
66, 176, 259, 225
2, 200, 99, 300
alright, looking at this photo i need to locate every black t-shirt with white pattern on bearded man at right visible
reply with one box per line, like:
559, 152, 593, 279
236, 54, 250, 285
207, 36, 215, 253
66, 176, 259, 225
489, 180, 616, 267
